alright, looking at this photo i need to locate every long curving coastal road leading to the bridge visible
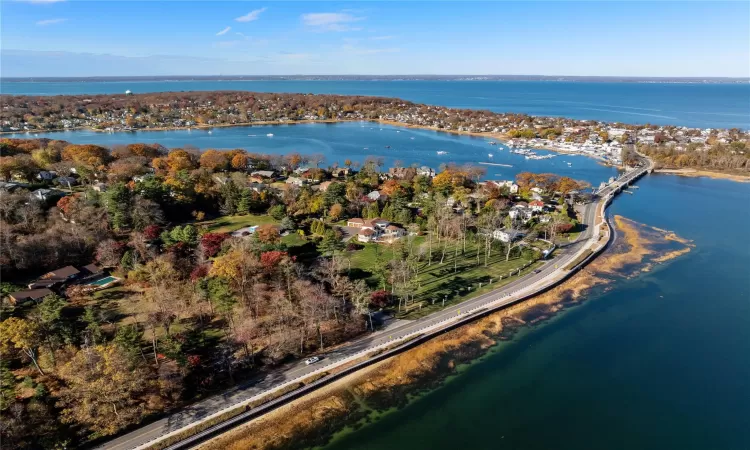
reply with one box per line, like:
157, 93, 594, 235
98, 163, 650, 450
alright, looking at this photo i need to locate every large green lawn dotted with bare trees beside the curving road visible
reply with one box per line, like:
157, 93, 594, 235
345, 237, 542, 319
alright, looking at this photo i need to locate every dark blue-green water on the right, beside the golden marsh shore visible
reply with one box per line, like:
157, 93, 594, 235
329, 175, 750, 450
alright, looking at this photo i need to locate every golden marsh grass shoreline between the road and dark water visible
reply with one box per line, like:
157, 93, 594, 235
198, 216, 694, 450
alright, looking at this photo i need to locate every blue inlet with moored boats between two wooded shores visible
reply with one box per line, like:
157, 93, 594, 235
5, 122, 617, 186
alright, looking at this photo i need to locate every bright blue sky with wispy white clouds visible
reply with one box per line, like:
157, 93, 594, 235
0, 0, 750, 77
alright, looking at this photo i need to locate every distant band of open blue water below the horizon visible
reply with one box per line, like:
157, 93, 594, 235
0, 81, 750, 129
